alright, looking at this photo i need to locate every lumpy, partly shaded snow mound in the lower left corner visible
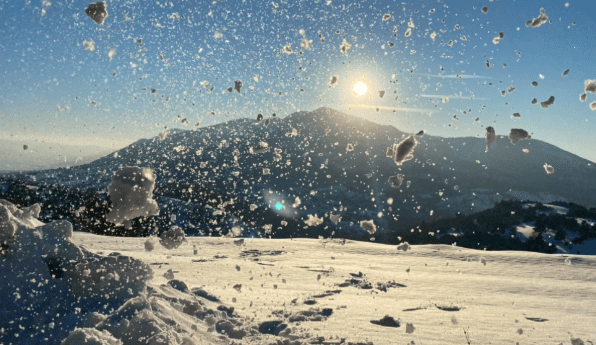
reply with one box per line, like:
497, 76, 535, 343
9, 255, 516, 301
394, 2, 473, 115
0, 199, 288, 345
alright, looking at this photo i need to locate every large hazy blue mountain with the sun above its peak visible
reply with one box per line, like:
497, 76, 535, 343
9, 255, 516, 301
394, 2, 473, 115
1, 108, 596, 239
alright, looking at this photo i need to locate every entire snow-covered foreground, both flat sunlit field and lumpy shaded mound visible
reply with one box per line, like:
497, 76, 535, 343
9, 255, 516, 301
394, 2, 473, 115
0, 201, 596, 344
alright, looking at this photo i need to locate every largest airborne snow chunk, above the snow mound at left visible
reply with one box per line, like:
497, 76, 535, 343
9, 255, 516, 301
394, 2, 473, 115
106, 167, 159, 228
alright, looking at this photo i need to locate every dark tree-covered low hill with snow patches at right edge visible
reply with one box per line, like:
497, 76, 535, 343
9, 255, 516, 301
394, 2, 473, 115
404, 200, 596, 255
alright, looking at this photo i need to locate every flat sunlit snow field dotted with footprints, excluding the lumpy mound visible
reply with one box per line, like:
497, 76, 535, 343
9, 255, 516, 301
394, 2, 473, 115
73, 233, 596, 344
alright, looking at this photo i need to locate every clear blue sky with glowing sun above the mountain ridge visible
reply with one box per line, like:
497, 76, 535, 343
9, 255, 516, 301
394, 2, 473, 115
0, 0, 596, 170
